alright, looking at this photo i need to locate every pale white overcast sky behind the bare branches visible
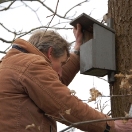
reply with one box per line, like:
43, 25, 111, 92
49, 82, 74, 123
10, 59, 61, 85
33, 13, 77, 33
0, 0, 110, 132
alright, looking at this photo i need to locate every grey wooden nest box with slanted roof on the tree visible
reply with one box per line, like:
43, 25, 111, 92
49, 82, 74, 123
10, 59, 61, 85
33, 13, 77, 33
70, 13, 116, 77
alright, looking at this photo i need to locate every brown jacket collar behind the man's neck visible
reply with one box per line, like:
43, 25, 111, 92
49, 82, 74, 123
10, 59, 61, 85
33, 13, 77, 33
13, 39, 51, 62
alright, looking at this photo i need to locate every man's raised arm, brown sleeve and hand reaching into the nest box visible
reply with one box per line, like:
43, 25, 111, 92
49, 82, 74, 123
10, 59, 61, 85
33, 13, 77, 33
61, 24, 83, 86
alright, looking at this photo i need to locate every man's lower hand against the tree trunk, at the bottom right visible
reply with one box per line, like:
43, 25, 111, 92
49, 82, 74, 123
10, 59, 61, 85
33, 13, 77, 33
114, 119, 132, 132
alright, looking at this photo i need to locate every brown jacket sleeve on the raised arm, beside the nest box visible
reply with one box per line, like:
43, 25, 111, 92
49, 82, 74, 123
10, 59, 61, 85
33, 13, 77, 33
60, 54, 80, 86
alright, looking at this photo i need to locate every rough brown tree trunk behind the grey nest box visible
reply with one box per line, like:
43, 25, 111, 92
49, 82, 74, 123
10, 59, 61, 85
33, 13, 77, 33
108, 0, 132, 117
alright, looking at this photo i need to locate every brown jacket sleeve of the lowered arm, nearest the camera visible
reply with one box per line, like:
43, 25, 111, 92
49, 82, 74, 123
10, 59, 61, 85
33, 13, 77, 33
20, 58, 114, 132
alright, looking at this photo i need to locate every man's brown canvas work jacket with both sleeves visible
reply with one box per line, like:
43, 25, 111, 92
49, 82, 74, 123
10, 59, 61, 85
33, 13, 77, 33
0, 39, 114, 132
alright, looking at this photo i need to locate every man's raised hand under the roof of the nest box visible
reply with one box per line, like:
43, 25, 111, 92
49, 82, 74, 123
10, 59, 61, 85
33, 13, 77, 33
73, 24, 83, 50
